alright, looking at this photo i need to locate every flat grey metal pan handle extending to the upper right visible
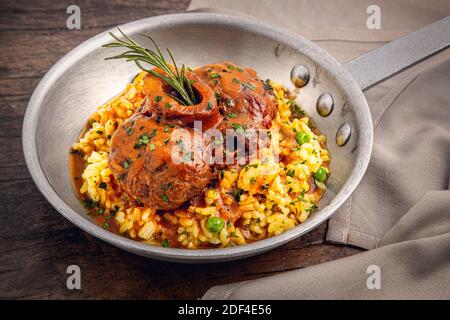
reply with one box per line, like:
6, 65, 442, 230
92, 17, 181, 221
344, 16, 450, 90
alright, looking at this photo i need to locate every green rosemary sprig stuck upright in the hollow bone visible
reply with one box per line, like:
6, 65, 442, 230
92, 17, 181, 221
103, 28, 196, 106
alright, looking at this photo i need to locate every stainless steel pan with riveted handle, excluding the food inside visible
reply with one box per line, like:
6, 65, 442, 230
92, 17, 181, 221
23, 13, 450, 263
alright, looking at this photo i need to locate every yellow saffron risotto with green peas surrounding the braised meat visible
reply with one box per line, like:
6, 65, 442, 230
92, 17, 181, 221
71, 72, 330, 249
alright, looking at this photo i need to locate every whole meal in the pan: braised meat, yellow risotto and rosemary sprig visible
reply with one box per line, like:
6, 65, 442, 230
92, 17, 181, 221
70, 33, 330, 249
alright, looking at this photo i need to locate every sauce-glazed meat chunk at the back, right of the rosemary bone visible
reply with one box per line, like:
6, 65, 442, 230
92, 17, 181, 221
195, 61, 276, 131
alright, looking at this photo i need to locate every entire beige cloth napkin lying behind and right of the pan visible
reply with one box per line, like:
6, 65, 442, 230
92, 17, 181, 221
189, 0, 450, 299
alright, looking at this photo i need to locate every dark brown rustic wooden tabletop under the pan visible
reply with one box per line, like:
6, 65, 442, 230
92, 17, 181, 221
0, 0, 359, 299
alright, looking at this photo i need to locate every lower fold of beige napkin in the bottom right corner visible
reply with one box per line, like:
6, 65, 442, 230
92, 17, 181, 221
203, 191, 450, 299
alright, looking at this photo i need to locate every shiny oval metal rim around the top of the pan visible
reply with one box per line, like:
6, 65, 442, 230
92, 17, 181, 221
22, 13, 373, 263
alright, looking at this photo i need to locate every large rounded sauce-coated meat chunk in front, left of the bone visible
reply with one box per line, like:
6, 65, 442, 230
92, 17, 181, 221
109, 113, 211, 210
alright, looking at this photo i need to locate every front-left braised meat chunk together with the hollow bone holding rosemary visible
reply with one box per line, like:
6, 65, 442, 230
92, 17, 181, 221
109, 68, 221, 210
